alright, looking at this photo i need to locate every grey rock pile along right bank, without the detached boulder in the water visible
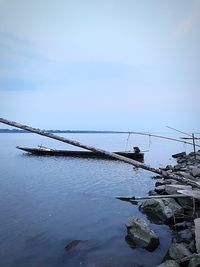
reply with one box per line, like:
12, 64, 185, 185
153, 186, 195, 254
140, 151, 200, 267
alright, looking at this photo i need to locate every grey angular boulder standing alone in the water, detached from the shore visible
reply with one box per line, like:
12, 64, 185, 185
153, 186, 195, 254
126, 217, 160, 251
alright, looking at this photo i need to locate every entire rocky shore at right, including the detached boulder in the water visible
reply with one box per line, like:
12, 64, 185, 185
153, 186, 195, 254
126, 151, 200, 267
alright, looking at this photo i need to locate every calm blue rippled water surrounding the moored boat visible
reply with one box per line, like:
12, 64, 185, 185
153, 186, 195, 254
0, 134, 194, 267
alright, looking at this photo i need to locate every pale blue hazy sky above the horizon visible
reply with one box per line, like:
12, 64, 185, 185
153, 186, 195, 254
0, 0, 200, 132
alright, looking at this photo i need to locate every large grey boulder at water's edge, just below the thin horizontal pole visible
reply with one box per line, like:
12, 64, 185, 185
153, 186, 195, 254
140, 198, 173, 223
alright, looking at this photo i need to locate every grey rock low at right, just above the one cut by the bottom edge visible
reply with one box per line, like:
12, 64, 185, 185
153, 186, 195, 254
168, 243, 191, 260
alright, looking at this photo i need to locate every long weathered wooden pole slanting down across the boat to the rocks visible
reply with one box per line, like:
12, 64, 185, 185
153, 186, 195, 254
0, 118, 200, 191
